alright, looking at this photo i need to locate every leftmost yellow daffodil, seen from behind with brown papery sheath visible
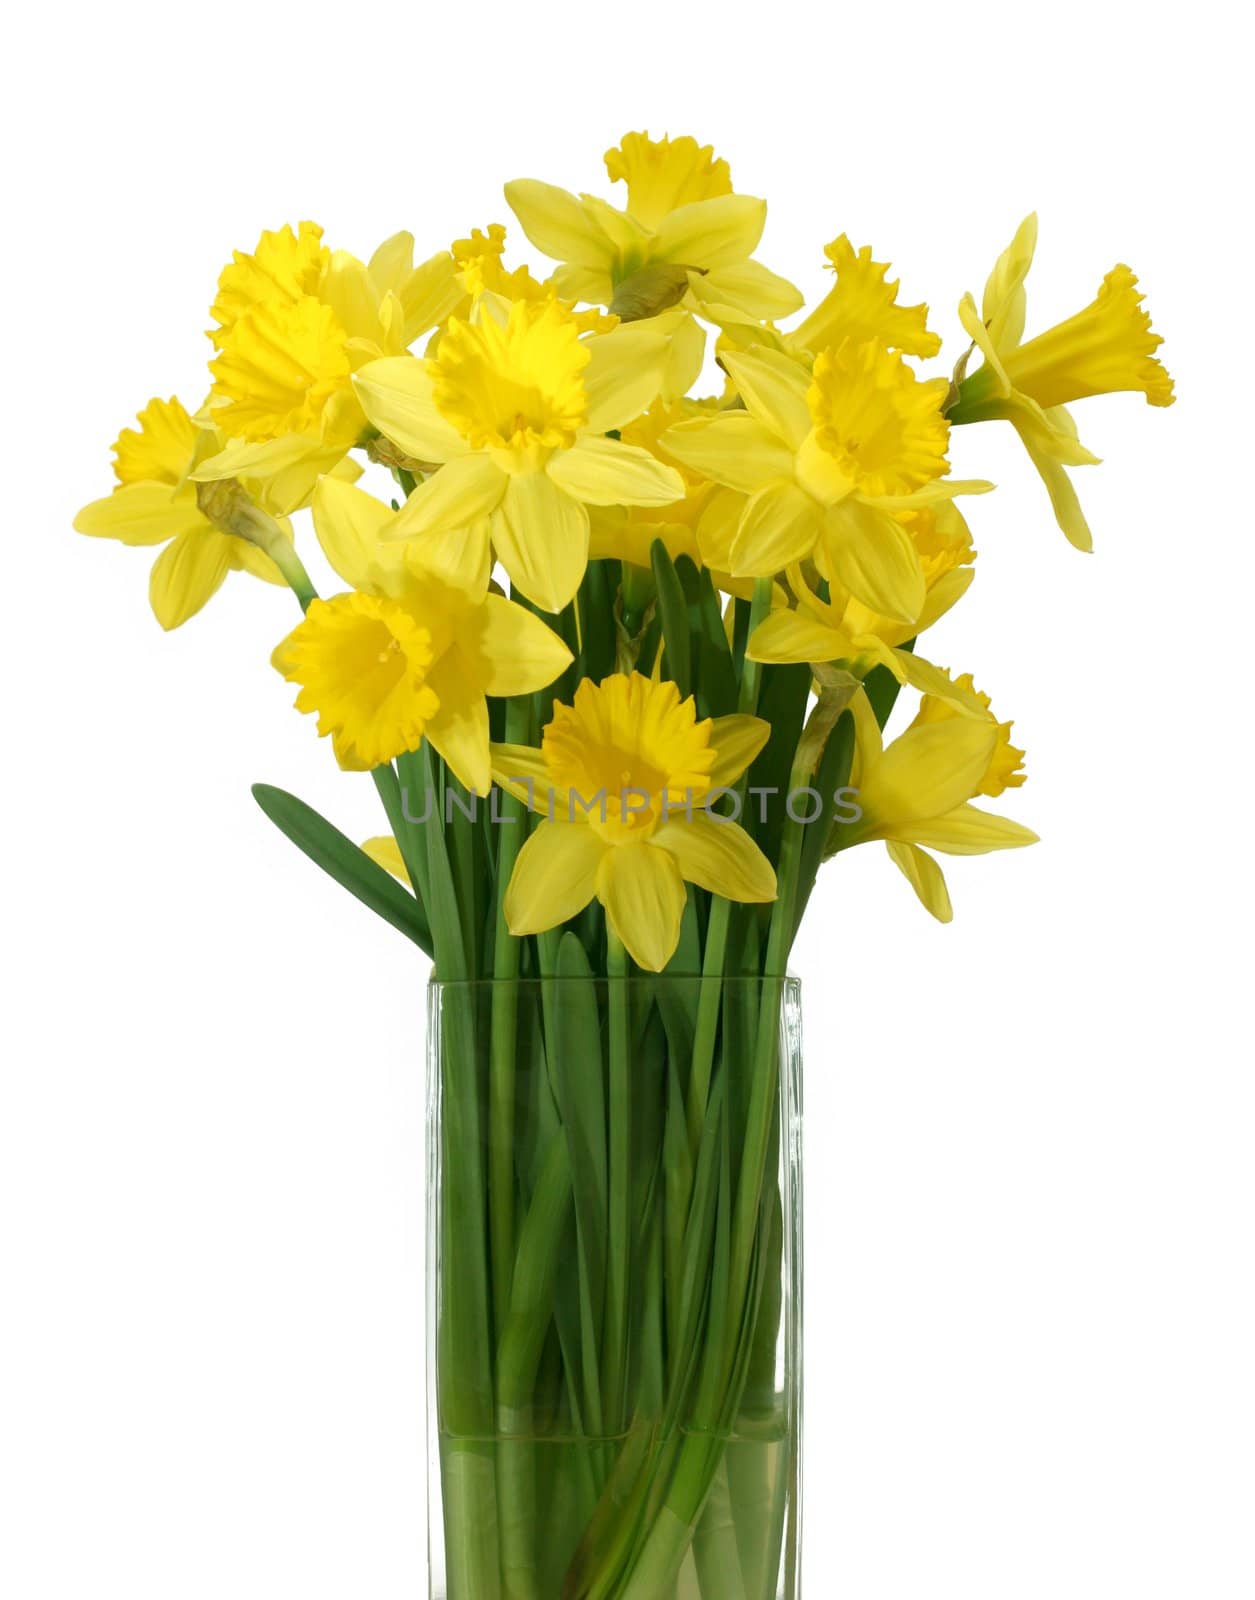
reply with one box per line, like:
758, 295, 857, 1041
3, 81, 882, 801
74, 398, 291, 629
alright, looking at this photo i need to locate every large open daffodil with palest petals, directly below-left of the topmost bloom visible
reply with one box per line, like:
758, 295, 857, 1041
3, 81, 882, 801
355, 294, 684, 611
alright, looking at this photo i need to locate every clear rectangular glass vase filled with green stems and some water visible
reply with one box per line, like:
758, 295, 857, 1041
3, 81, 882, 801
427, 963, 802, 1600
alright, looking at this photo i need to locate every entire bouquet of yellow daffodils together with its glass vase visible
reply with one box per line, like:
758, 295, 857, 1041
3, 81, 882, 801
75, 134, 1172, 1600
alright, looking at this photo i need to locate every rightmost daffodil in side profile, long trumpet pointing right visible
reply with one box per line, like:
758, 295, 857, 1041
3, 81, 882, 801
949, 216, 1173, 550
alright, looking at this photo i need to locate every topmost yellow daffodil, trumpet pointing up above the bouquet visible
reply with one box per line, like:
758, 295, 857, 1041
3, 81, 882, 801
506, 133, 802, 398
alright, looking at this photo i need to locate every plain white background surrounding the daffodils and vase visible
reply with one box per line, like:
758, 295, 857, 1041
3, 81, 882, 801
0, 0, 1255, 1600
